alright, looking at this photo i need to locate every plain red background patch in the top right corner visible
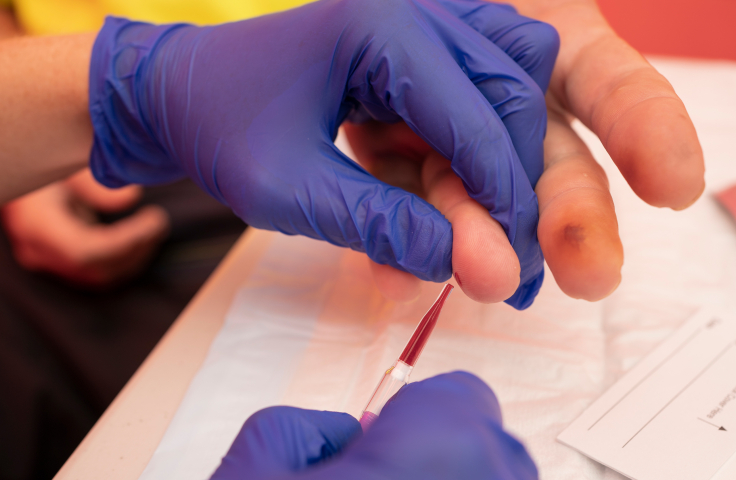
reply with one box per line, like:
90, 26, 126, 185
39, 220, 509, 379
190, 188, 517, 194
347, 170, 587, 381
598, 0, 736, 61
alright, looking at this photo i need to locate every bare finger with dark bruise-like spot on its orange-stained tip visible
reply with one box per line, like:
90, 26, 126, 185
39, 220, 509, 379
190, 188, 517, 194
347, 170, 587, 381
536, 109, 623, 301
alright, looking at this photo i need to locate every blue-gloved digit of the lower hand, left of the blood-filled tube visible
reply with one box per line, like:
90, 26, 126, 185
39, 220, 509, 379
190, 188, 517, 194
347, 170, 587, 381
211, 407, 362, 480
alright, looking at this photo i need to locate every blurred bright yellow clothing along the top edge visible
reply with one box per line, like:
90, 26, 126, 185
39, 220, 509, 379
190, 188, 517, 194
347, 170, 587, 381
12, 0, 311, 35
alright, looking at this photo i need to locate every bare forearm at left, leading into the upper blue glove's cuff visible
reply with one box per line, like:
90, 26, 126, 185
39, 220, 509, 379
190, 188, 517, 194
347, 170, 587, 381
0, 33, 95, 203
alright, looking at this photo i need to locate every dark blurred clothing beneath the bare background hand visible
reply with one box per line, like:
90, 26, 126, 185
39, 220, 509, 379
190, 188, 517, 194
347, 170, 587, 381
0, 180, 245, 480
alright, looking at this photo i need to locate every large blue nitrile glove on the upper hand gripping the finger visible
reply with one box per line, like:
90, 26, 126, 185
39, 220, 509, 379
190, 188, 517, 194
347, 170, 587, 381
90, 0, 551, 308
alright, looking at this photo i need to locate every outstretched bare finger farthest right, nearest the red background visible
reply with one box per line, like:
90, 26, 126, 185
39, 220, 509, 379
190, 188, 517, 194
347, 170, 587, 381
520, 1, 705, 210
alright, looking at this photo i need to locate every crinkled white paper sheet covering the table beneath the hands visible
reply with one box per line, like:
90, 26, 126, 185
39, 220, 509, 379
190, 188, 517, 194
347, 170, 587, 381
141, 60, 736, 480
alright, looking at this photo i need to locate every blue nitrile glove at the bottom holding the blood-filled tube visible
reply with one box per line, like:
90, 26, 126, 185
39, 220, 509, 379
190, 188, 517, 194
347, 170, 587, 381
211, 372, 537, 480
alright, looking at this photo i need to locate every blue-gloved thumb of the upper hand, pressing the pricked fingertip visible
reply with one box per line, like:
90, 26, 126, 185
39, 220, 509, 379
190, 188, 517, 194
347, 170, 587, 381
239, 146, 452, 282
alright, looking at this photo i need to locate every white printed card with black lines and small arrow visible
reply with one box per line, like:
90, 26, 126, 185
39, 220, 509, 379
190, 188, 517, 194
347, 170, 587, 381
557, 311, 736, 480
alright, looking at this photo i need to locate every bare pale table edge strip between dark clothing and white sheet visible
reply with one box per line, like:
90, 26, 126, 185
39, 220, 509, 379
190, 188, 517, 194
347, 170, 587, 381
54, 229, 275, 480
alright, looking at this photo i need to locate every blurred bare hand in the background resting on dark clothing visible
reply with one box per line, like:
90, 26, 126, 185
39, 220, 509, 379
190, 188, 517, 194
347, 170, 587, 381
2, 170, 169, 287
